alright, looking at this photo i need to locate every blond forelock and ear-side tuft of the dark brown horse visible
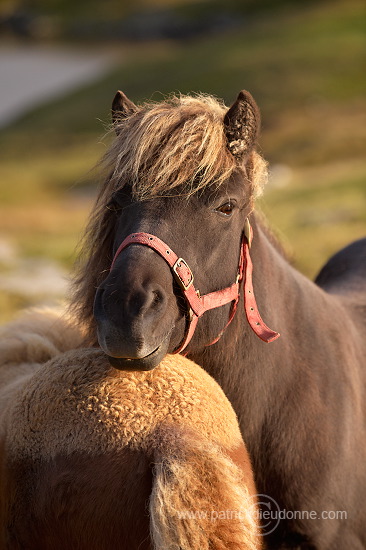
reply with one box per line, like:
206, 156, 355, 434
102, 94, 263, 200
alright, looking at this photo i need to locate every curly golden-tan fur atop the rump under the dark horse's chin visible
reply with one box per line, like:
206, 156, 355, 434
9, 349, 241, 459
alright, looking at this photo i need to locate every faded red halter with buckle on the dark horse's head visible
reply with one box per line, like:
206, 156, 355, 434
110, 220, 280, 353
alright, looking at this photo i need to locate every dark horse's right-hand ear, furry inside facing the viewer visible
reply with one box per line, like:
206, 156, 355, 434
224, 90, 260, 160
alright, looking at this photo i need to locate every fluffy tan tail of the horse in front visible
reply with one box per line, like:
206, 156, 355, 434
150, 437, 260, 550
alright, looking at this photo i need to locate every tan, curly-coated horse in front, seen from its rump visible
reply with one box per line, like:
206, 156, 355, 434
0, 312, 261, 550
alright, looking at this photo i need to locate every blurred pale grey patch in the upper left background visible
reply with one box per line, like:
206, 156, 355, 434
0, 45, 114, 128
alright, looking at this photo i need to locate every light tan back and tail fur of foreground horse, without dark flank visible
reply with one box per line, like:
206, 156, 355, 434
0, 312, 260, 550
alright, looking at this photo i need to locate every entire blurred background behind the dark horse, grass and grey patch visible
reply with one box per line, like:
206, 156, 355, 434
0, 0, 366, 322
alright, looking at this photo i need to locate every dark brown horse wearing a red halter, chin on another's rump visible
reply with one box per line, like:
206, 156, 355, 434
73, 92, 366, 550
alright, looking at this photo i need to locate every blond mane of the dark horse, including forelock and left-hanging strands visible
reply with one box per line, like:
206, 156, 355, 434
72, 94, 267, 343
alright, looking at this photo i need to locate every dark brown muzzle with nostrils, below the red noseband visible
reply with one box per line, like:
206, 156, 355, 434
94, 247, 185, 370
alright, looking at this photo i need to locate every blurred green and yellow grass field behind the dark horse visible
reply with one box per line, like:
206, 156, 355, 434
0, 0, 366, 321
